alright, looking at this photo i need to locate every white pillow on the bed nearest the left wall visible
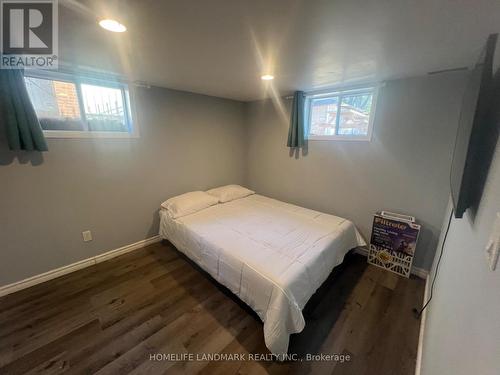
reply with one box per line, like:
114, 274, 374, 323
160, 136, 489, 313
161, 191, 219, 219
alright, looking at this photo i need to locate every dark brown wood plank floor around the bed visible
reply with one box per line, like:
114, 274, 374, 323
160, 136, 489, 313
0, 242, 424, 375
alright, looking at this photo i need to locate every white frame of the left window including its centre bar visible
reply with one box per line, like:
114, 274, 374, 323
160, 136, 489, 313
24, 69, 139, 139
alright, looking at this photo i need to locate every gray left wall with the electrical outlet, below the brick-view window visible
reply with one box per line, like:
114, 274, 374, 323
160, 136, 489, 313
0, 88, 245, 285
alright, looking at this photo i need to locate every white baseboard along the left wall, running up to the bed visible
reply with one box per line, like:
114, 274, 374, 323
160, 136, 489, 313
0, 236, 161, 297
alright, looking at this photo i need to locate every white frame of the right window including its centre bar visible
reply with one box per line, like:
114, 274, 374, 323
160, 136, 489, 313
305, 84, 379, 142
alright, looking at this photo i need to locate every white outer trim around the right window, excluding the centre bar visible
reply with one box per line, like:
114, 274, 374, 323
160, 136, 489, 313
305, 84, 381, 142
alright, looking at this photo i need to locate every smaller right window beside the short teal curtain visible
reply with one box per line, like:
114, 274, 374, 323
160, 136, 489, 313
306, 87, 376, 141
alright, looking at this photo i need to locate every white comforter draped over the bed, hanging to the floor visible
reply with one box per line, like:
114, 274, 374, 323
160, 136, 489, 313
160, 194, 366, 355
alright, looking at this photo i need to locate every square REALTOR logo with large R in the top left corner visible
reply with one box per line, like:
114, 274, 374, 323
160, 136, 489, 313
0, 0, 57, 69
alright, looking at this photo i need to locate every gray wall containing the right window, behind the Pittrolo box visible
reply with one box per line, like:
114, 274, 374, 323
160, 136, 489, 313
245, 73, 465, 269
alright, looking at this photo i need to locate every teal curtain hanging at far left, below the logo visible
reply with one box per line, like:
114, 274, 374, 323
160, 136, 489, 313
0, 69, 48, 151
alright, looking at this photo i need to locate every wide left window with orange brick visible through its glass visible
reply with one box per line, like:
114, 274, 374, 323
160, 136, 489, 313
24, 71, 138, 138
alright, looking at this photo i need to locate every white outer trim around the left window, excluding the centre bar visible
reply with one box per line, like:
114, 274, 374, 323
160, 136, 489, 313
24, 69, 140, 139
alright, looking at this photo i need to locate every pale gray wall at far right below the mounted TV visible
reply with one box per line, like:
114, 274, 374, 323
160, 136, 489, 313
421, 143, 500, 375
